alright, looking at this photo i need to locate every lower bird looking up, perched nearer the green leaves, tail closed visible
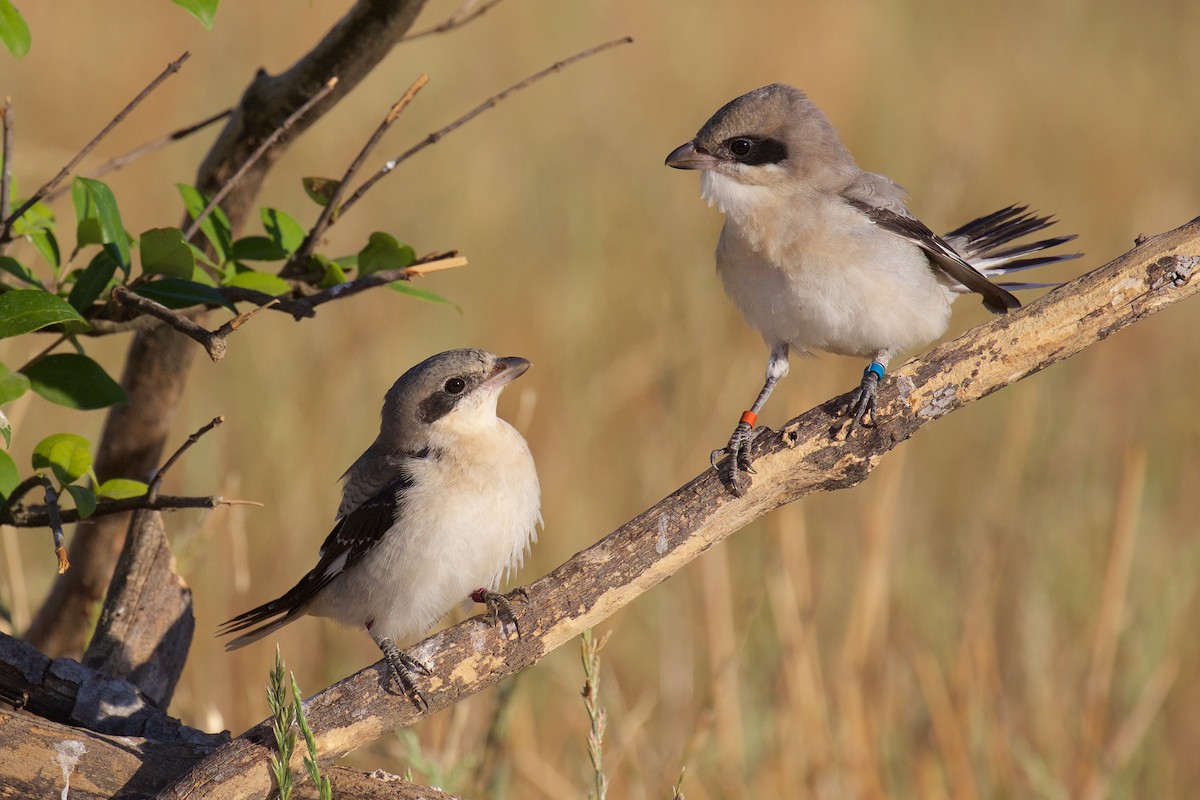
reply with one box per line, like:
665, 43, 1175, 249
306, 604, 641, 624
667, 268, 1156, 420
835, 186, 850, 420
218, 349, 542, 708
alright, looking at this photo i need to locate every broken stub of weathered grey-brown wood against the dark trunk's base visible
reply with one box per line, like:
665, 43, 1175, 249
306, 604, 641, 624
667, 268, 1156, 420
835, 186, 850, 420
83, 511, 196, 709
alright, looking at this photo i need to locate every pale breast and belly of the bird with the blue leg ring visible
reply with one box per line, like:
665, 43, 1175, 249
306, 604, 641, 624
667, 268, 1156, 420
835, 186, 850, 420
716, 181, 953, 357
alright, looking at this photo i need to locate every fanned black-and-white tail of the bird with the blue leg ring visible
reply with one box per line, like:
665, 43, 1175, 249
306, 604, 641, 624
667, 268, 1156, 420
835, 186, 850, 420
942, 205, 1082, 293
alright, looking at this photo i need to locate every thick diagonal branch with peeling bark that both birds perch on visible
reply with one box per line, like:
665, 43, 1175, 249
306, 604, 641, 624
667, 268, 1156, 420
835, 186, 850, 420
160, 219, 1200, 799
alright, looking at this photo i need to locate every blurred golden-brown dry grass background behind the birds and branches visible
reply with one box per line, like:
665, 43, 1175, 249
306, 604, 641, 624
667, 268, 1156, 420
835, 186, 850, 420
0, 0, 1200, 800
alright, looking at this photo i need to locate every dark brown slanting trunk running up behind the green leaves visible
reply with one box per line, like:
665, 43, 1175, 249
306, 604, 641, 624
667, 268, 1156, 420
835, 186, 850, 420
26, 0, 425, 655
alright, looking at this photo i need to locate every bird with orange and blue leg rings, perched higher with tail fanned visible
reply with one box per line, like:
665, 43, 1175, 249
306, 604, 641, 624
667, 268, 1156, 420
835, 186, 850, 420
666, 83, 1080, 493
